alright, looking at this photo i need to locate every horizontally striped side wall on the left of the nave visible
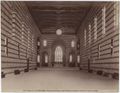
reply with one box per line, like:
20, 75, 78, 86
1, 1, 40, 74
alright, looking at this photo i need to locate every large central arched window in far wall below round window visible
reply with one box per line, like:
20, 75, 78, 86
55, 46, 63, 62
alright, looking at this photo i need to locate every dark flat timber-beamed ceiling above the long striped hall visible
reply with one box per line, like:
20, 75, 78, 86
26, 1, 91, 34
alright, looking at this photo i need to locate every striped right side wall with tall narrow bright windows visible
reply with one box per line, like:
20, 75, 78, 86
78, 2, 119, 73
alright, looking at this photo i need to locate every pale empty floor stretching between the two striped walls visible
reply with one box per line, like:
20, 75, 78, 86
2, 68, 119, 93
